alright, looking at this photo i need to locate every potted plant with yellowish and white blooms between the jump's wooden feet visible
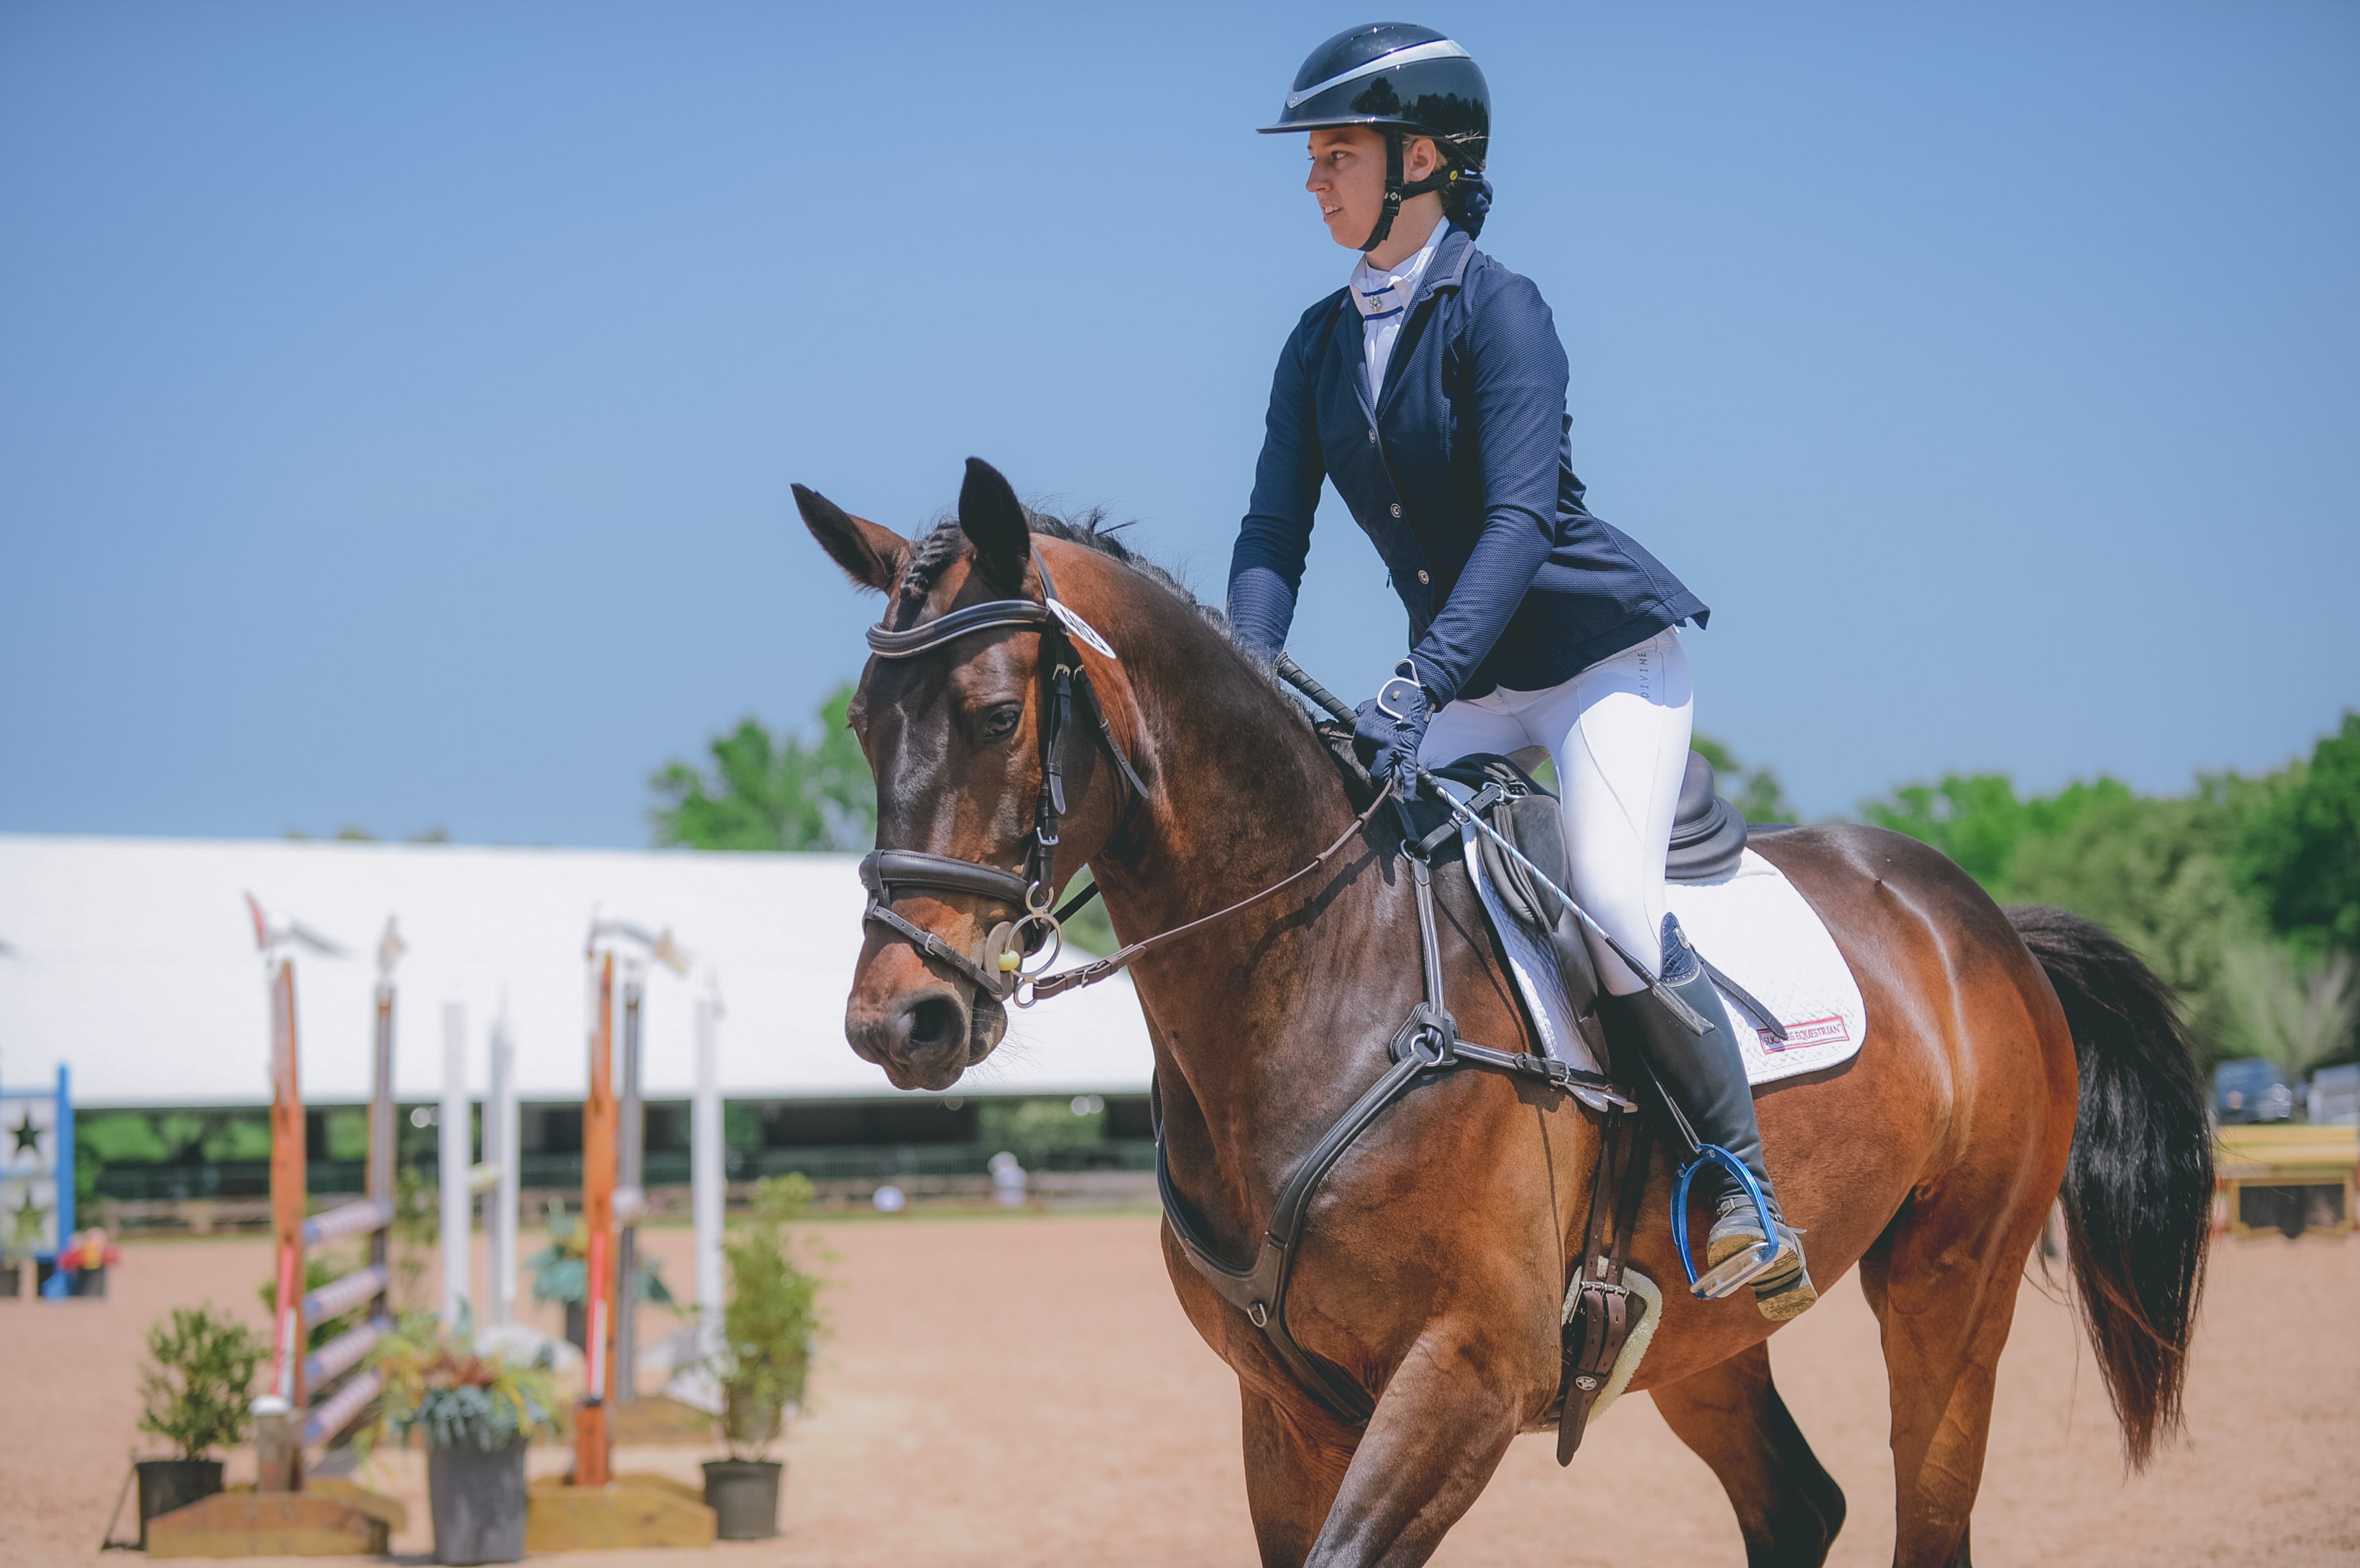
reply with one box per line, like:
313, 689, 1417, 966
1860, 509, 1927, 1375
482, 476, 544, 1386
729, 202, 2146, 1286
356, 1313, 557, 1564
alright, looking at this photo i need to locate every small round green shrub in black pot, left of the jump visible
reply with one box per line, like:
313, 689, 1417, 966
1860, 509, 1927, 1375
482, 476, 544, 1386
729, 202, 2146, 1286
135, 1302, 269, 1551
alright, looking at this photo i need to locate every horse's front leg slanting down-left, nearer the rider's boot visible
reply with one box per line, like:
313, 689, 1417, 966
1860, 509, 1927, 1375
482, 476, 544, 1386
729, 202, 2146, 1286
1283, 1318, 1555, 1568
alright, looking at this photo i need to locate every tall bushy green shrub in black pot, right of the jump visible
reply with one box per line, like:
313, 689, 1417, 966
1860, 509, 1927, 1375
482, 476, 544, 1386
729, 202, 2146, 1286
706, 1174, 824, 1540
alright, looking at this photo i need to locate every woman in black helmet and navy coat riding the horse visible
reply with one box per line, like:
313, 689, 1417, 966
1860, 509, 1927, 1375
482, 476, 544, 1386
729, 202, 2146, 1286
1230, 21, 1817, 1318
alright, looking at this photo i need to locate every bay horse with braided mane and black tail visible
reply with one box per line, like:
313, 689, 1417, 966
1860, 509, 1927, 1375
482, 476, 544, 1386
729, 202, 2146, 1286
796, 460, 2211, 1565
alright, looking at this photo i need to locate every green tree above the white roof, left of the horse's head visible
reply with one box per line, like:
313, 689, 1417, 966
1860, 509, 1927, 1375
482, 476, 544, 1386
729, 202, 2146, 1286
649, 686, 878, 849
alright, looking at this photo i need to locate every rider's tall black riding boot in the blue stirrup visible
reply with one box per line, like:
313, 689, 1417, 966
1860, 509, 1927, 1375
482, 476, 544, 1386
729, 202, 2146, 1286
1605, 915, 1820, 1323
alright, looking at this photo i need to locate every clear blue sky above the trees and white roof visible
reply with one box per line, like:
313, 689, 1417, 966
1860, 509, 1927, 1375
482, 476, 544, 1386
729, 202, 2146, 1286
0, 0, 2360, 844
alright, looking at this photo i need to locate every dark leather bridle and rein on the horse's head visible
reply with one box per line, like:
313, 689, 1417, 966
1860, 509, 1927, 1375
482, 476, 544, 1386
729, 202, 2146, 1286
861, 554, 1393, 1007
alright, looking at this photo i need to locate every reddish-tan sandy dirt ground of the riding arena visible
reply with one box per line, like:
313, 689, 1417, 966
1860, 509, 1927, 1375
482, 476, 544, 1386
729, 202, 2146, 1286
0, 1214, 2360, 1568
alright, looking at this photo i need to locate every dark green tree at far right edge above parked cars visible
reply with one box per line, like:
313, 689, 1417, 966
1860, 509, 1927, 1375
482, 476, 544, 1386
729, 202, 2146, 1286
2237, 712, 2360, 953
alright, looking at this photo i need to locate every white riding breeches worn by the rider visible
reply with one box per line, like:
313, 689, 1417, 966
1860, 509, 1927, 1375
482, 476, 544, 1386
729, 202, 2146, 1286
1418, 627, 1695, 995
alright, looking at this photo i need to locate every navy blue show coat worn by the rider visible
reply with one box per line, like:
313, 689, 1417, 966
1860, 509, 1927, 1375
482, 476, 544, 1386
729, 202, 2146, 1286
1230, 227, 1711, 703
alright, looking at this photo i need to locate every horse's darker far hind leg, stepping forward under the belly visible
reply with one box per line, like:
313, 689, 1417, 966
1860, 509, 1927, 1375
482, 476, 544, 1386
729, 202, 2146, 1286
1652, 1344, 1843, 1568
